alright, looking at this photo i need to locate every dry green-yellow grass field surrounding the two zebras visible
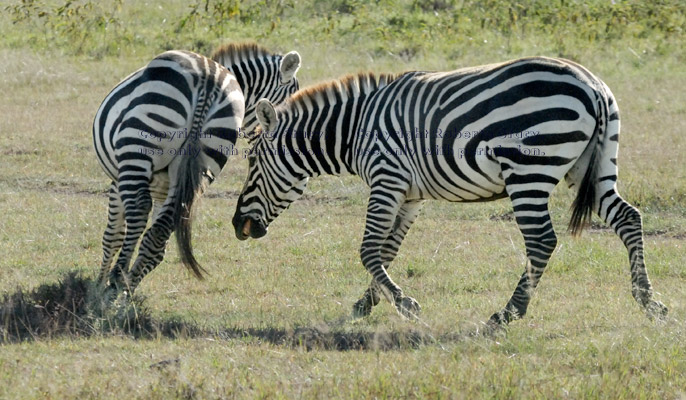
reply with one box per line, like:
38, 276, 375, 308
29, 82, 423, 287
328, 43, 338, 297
0, 0, 686, 399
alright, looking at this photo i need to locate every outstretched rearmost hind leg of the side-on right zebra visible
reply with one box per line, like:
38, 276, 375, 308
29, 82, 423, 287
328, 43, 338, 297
598, 190, 668, 319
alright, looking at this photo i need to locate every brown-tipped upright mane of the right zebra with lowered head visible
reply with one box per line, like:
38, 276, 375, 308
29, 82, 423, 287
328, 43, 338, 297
284, 72, 401, 104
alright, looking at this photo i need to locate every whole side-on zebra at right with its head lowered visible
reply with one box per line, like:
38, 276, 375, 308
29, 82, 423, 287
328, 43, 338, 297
233, 57, 667, 326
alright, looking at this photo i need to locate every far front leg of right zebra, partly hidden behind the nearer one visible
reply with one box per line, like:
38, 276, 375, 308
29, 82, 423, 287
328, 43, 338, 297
353, 200, 424, 318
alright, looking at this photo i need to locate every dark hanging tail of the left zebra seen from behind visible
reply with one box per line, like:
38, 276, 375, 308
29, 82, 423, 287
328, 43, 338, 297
174, 132, 206, 279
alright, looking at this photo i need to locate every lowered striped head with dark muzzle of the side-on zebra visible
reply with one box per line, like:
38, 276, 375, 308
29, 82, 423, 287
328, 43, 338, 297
232, 99, 310, 240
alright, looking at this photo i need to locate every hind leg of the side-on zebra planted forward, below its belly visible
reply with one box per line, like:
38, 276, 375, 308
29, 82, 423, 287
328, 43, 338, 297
488, 195, 557, 326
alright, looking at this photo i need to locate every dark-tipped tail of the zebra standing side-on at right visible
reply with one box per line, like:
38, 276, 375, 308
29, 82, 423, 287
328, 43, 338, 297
567, 92, 608, 237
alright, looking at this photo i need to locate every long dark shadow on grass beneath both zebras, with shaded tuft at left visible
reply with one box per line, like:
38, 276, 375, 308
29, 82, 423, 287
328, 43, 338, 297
0, 272, 494, 351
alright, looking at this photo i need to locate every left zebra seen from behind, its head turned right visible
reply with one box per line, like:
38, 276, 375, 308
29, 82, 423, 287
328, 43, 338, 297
93, 43, 300, 292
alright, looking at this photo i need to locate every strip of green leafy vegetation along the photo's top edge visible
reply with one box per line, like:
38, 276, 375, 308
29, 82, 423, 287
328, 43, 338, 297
4, 0, 686, 58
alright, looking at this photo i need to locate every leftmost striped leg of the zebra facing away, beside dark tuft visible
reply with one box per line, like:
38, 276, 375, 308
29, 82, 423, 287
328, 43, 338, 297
98, 182, 126, 285
